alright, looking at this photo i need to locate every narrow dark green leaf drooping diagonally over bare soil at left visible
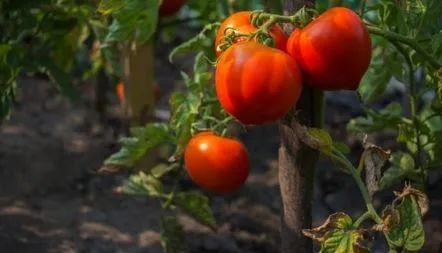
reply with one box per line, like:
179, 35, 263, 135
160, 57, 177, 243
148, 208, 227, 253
43, 59, 81, 102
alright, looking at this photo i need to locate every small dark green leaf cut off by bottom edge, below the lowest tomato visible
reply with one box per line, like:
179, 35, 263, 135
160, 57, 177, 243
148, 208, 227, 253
160, 216, 186, 253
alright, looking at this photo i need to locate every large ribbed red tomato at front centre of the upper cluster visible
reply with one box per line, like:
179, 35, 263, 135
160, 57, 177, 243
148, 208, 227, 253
215, 41, 302, 125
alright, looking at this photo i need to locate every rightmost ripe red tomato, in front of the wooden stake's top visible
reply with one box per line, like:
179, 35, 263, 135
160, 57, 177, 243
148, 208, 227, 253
287, 7, 371, 90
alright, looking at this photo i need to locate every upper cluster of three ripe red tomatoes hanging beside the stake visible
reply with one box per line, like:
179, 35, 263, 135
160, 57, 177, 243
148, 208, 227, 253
215, 7, 371, 125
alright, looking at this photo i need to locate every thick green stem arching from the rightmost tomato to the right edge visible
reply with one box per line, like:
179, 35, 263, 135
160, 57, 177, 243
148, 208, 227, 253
367, 24, 442, 69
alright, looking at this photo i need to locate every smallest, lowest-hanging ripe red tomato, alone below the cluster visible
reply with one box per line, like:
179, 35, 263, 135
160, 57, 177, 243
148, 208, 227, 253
184, 132, 250, 193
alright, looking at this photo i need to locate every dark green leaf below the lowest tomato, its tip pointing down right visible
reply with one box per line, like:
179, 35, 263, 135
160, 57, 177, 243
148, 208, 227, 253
174, 191, 216, 229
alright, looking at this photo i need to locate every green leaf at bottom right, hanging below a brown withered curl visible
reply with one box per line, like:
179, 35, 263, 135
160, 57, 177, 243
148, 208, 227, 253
386, 195, 425, 251
